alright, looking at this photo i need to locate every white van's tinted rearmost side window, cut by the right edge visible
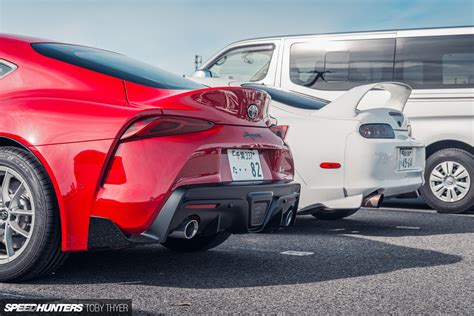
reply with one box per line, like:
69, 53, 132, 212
395, 35, 474, 89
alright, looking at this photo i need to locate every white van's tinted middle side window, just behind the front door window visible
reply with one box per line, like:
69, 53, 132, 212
290, 39, 395, 90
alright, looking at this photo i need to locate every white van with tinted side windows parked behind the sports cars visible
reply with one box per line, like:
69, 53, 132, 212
193, 26, 474, 213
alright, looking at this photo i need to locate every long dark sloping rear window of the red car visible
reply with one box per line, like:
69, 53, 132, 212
31, 43, 204, 90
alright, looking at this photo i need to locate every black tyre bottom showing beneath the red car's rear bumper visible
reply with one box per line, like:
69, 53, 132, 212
163, 232, 231, 252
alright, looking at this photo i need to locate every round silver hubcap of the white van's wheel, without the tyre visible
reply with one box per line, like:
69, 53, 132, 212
429, 161, 471, 203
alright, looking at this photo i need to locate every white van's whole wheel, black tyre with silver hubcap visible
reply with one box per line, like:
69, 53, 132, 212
420, 148, 474, 214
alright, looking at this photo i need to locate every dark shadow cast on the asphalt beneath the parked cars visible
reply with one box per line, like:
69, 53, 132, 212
24, 210, 464, 289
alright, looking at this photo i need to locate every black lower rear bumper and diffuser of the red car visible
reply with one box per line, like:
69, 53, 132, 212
88, 183, 300, 248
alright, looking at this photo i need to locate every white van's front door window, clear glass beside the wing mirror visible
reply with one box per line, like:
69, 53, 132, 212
208, 45, 274, 82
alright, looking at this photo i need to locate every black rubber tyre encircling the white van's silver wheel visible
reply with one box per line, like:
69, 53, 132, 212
420, 148, 474, 214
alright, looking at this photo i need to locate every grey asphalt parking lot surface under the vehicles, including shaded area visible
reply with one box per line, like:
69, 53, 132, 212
0, 205, 474, 314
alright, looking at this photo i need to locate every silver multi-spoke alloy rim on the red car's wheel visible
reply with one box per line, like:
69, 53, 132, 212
0, 166, 35, 264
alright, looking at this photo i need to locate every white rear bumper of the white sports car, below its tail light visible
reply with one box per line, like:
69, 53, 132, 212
296, 133, 425, 212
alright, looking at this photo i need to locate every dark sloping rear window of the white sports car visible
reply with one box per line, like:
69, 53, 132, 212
242, 84, 329, 110
